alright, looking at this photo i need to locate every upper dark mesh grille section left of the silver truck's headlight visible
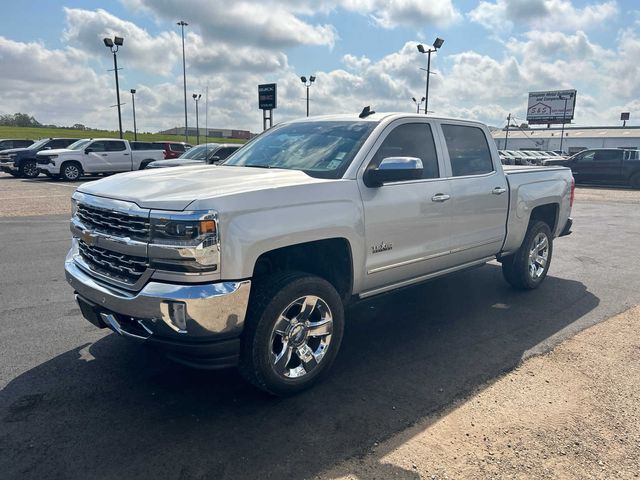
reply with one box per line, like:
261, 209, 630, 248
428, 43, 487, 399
76, 203, 149, 240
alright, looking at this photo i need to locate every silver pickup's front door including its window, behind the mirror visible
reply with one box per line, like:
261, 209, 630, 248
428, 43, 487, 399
358, 119, 451, 291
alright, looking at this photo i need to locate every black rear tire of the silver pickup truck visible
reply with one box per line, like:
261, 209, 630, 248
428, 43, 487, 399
502, 221, 553, 290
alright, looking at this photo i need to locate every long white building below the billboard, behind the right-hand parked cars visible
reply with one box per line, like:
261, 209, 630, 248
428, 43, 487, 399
492, 126, 640, 153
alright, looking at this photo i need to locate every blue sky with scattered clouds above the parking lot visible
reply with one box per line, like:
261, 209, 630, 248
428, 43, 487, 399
0, 0, 640, 131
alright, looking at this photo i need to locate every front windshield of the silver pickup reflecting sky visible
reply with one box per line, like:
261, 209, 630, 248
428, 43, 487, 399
224, 121, 377, 178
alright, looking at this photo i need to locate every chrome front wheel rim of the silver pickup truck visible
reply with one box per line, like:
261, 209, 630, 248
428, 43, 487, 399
270, 295, 333, 378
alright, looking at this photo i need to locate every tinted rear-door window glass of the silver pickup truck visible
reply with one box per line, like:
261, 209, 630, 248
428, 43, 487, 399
442, 125, 493, 177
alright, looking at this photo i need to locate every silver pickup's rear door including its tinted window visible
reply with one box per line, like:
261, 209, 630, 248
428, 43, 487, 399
440, 122, 509, 265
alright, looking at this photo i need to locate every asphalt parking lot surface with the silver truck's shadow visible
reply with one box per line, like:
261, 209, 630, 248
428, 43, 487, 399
0, 174, 640, 479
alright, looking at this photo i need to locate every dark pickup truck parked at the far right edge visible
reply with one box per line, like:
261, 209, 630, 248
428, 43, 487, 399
545, 148, 640, 188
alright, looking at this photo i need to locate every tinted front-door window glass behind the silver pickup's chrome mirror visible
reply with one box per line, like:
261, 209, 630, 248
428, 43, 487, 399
371, 123, 440, 178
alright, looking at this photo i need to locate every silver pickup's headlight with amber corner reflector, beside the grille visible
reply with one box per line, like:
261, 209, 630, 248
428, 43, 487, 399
149, 211, 220, 272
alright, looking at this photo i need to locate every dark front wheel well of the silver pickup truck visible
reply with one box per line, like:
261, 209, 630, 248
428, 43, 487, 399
253, 238, 353, 302
